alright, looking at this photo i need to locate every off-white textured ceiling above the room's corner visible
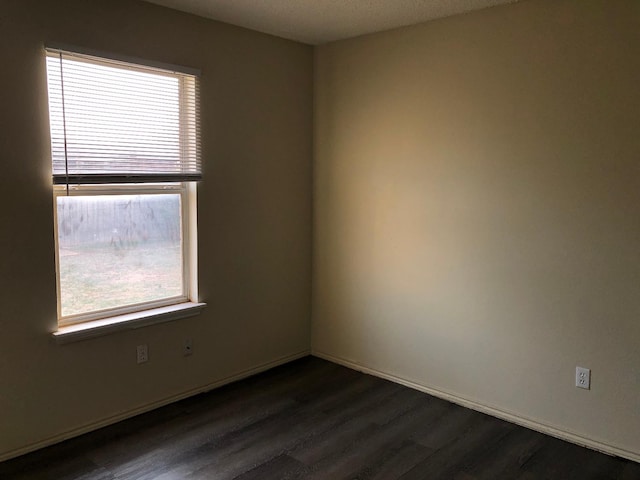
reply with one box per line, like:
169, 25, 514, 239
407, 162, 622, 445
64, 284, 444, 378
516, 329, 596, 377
146, 0, 518, 45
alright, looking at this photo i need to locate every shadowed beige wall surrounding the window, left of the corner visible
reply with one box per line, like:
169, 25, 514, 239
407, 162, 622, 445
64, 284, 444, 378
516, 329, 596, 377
0, 0, 313, 458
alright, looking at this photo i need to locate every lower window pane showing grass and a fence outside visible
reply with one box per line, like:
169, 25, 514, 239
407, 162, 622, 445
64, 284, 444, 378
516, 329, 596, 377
57, 194, 183, 317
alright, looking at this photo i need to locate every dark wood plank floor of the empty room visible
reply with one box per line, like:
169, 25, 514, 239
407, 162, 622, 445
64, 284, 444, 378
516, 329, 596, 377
0, 357, 640, 480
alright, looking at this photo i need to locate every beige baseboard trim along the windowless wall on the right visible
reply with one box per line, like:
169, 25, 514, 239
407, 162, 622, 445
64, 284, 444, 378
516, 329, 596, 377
311, 350, 640, 463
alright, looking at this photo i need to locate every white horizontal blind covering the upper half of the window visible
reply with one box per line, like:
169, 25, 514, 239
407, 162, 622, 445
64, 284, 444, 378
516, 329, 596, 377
47, 49, 202, 185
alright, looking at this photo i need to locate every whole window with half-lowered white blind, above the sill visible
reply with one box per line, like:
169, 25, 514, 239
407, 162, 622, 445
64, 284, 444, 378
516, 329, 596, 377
46, 48, 201, 327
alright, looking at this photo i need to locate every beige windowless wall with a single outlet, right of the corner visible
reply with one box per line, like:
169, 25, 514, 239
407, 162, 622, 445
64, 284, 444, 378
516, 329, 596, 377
312, 0, 640, 459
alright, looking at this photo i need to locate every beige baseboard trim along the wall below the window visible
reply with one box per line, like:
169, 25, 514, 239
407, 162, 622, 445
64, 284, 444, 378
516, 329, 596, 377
0, 350, 311, 462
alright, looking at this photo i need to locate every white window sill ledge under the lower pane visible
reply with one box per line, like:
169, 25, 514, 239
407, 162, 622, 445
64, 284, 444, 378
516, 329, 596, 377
52, 302, 207, 344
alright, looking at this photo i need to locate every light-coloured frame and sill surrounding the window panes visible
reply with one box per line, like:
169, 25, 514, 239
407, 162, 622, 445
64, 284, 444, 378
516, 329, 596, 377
44, 45, 205, 330
